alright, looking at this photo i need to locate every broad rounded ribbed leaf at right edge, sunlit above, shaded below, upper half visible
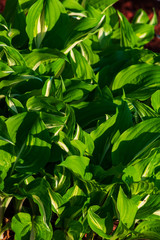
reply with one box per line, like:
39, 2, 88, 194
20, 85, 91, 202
112, 63, 160, 100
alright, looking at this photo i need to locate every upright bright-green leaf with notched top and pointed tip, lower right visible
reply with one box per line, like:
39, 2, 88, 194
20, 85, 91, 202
117, 187, 141, 228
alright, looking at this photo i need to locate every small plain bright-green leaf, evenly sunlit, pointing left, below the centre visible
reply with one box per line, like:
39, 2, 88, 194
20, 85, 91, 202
59, 156, 89, 178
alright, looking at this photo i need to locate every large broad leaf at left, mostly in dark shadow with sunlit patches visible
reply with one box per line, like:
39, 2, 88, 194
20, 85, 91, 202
6, 113, 51, 173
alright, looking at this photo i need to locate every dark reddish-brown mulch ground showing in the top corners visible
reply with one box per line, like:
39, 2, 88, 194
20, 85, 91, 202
0, 0, 160, 52
